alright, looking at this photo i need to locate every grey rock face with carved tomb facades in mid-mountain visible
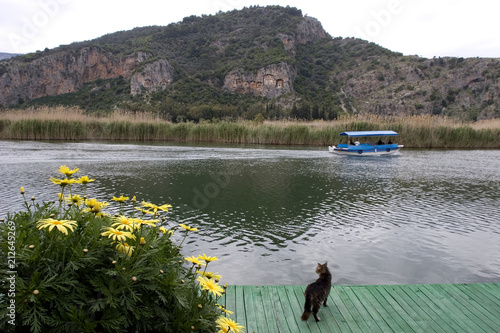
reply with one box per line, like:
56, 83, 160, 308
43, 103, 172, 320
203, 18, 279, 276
223, 63, 297, 98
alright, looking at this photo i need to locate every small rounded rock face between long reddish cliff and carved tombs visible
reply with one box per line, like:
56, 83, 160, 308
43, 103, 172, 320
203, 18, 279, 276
130, 59, 175, 96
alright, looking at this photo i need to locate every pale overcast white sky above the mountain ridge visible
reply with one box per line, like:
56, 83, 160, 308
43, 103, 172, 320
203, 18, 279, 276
0, 0, 500, 58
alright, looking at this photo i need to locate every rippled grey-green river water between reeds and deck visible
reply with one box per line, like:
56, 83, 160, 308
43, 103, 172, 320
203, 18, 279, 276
0, 141, 500, 285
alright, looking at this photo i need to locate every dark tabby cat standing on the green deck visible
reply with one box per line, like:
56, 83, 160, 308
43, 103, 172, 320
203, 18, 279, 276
300, 262, 332, 321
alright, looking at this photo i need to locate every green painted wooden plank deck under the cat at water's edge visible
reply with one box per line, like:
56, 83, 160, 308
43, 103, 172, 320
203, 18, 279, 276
219, 283, 500, 333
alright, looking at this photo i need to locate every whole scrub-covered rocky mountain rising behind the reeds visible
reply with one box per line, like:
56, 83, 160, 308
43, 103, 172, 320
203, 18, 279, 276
0, 6, 500, 121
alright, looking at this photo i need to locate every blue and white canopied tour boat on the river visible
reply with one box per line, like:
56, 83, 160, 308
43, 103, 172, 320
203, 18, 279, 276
328, 131, 403, 156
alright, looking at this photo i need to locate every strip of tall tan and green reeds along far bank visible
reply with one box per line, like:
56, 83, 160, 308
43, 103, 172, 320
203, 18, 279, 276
0, 107, 500, 148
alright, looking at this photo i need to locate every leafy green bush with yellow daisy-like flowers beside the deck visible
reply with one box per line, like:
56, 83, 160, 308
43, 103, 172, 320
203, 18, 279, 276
0, 166, 243, 332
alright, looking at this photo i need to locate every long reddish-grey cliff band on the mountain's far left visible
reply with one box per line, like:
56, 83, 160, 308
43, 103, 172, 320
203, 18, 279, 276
0, 47, 149, 106
